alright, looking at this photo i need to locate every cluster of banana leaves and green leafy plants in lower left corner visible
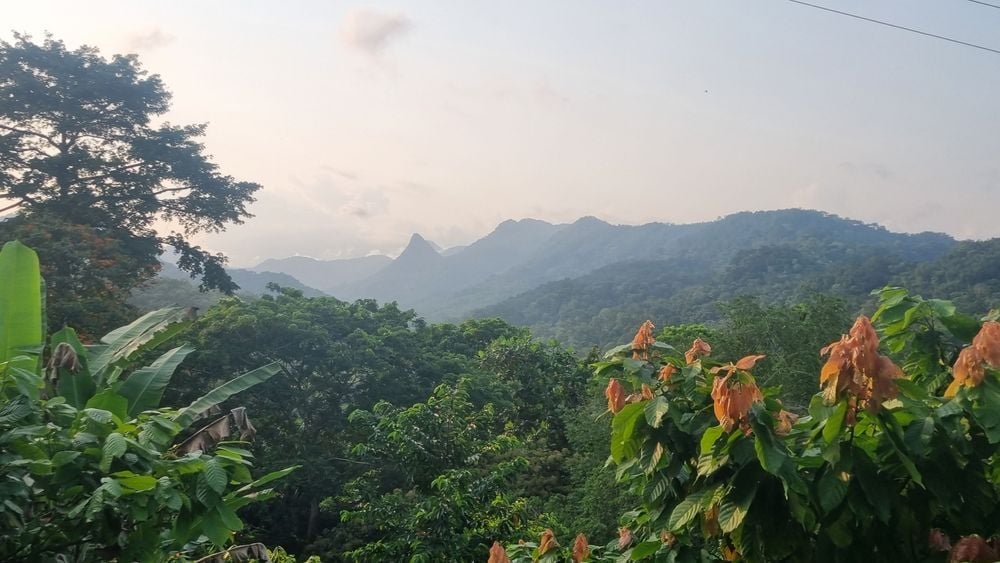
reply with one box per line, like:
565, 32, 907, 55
0, 242, 292, 561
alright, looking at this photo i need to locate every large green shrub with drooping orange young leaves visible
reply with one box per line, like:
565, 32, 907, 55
596, 288, 1000, 561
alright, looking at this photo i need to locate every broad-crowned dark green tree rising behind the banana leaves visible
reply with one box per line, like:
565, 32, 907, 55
168, 294, 540, 559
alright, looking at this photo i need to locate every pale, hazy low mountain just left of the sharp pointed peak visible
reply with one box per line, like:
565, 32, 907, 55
250, 255, 392, 293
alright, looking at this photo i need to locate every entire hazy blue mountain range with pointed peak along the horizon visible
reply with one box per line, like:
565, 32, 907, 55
137, 209, 1000, 346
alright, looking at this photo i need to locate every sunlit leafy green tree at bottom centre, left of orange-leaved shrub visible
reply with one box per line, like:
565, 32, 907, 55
342, 381, 533, 562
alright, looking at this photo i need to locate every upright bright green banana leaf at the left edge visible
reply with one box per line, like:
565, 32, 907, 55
0, 241, 44, 371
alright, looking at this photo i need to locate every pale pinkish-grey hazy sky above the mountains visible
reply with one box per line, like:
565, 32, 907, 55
0, 0, 1000, 266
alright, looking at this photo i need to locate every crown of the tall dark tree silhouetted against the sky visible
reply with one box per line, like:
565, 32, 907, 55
0, 34, 260, 308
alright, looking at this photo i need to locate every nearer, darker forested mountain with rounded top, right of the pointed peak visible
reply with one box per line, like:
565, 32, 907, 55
471, 210, 960, 348
